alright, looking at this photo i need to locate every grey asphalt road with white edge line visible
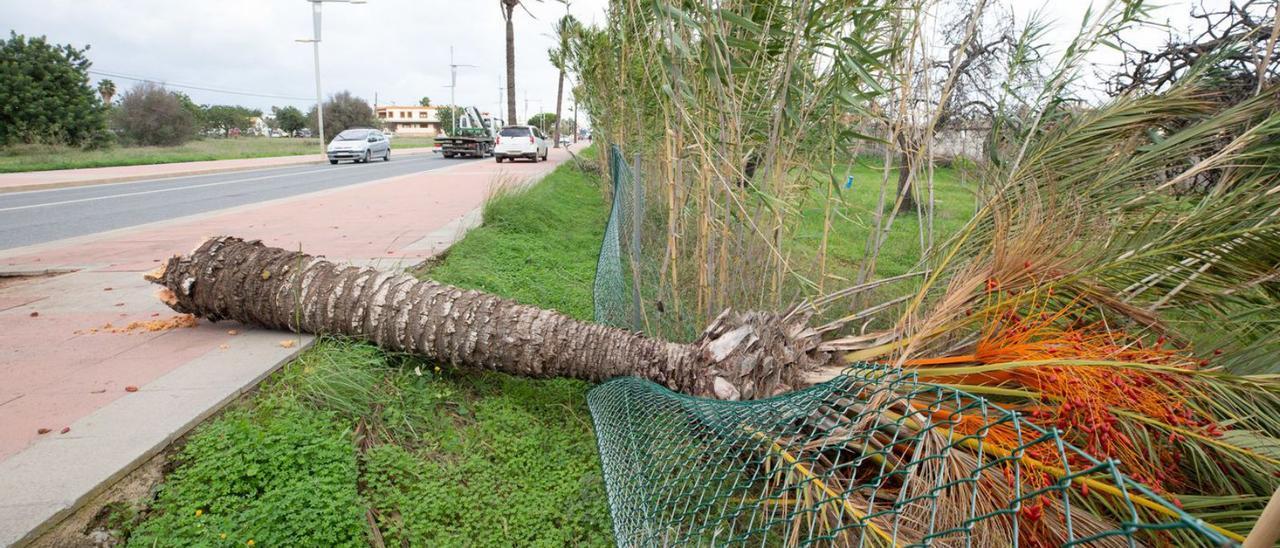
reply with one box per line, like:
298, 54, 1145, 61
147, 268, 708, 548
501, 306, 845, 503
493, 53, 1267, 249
0, 152, 474, 250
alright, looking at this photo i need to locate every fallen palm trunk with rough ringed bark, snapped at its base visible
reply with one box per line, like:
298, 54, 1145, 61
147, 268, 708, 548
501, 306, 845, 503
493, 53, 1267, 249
147, 237, 835, 399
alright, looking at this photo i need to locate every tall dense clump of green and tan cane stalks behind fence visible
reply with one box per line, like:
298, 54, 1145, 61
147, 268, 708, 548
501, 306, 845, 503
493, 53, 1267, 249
571, 0, 893, 338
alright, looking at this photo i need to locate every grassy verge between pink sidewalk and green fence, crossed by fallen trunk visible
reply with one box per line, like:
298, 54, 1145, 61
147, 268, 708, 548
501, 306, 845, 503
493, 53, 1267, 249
127, 160, 612, 547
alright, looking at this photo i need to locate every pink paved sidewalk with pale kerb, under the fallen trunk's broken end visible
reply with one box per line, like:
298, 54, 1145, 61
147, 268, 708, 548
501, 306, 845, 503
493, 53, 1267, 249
0, 145, 568, 545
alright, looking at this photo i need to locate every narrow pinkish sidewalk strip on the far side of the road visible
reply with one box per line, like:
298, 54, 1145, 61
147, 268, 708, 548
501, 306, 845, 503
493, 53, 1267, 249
0, 147, 431, 192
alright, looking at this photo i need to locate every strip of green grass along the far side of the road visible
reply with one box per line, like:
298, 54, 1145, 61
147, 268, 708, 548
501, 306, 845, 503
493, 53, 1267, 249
0, 137, 434, 173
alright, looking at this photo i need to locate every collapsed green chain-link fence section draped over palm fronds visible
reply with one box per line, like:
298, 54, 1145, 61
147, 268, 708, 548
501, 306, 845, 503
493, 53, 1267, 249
588, 365, 1230, 547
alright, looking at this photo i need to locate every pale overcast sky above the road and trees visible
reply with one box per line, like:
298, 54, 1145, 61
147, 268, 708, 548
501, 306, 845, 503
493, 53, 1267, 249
0, 0, 1228, 118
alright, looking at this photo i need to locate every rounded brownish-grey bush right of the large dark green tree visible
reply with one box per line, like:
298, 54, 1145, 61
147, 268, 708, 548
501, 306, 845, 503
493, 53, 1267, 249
113, 83, 196, 146
